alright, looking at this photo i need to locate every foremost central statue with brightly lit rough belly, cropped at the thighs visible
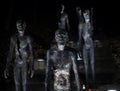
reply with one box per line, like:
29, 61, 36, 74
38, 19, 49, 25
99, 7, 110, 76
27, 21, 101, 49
45, 29, 80, 91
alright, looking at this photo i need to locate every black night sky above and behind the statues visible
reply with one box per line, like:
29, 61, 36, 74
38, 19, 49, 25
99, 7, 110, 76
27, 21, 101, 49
1, 0, 119, 42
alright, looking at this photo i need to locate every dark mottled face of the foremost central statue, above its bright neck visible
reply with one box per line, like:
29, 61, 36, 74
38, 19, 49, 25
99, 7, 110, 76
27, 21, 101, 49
55, 30, 68, 45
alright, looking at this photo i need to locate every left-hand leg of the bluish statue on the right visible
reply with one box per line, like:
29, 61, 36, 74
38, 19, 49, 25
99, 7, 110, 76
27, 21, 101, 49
83, 46, 88, 82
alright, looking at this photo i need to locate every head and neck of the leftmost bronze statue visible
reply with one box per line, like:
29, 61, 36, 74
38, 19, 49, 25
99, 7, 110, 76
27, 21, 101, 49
16, 20, 26, 36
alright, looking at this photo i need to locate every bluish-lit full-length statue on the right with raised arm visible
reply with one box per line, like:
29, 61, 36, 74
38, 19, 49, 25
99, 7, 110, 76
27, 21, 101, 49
76, 8, 95, 84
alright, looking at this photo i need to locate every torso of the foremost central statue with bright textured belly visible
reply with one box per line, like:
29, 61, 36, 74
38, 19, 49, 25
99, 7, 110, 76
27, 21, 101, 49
51, 50, 72, 91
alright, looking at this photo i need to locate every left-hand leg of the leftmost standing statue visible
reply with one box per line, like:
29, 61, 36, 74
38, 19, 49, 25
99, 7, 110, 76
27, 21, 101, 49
14, 67, 21, 91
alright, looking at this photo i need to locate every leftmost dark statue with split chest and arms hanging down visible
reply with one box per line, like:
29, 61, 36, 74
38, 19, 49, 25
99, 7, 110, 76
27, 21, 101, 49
4, 20, 34, 91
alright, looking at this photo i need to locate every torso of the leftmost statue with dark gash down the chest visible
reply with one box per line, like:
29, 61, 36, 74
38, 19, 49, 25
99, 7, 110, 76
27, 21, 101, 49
15, 36, 28, 65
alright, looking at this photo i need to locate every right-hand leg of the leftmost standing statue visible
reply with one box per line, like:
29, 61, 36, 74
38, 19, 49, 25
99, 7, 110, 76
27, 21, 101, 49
22, 66, 27, 91
